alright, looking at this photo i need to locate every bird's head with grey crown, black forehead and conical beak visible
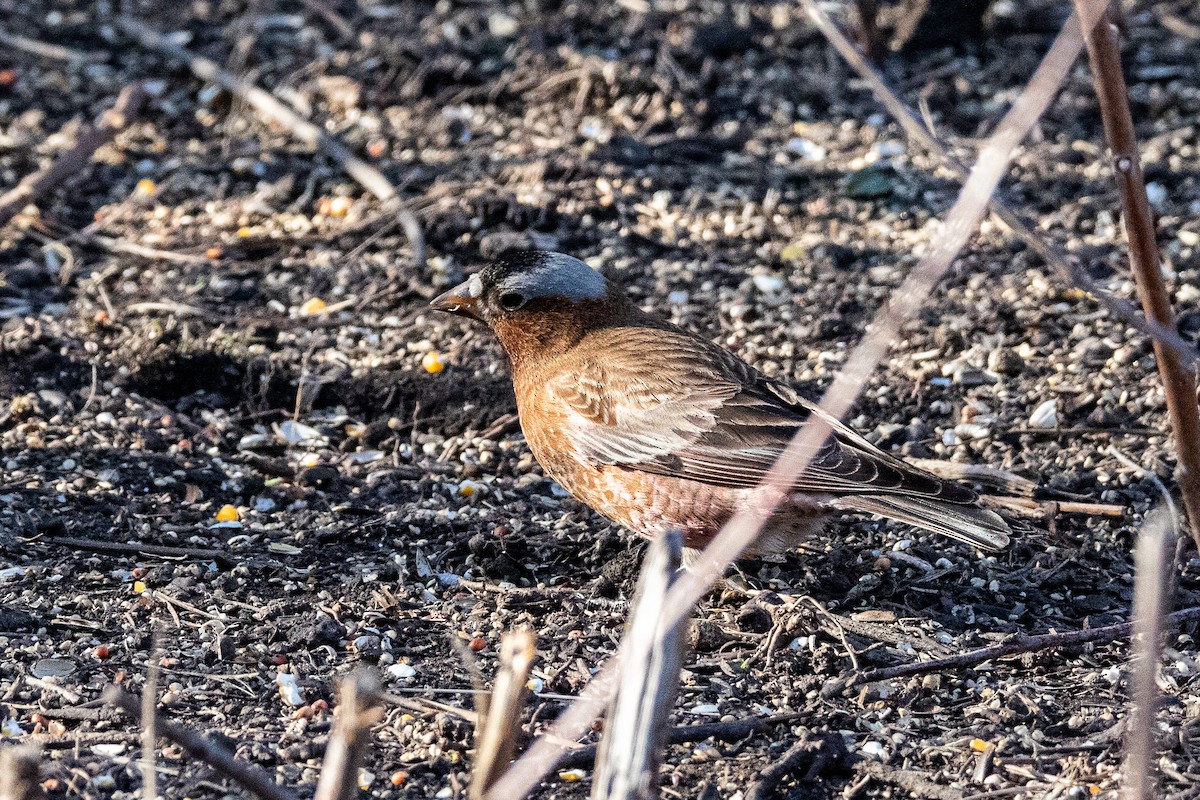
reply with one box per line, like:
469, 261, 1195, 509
430, 251, 631, 362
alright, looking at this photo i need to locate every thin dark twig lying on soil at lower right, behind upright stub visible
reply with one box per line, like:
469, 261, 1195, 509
821, 608, 1200, 697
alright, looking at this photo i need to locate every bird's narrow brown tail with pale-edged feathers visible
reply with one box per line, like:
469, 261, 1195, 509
833, 494, 1013, 551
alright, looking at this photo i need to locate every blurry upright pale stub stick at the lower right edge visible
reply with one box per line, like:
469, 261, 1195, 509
1122, 509, 1175, 800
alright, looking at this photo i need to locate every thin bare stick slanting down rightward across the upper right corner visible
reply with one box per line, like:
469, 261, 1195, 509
800, 0, 1200, 374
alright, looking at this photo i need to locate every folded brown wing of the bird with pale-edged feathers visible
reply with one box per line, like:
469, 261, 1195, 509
546, 327, 976, 503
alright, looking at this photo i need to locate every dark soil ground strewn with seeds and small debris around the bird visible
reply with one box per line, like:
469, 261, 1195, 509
0, 0, 1200, 800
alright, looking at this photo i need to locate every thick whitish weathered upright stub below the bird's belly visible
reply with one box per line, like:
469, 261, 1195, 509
592, 530, 688, 800
